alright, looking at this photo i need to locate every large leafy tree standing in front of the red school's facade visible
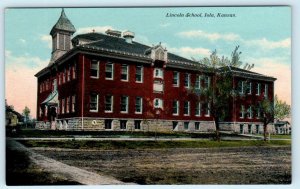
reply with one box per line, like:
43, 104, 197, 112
192, 46, 246, 141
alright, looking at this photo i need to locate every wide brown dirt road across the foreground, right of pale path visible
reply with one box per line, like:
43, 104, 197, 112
33, 146, 291, 184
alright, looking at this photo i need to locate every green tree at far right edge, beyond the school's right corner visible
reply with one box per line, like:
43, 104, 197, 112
274, 95, 291, 121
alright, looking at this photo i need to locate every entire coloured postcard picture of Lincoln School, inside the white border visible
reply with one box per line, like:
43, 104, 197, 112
4, 6, 293, 186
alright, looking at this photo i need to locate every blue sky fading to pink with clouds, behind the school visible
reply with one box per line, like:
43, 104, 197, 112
4, 6, 291, 117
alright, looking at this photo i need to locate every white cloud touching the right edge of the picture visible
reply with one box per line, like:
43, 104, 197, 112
244, 38, 291, 49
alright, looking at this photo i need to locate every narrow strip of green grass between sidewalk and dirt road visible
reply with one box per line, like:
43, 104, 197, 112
19, 140, 291, 149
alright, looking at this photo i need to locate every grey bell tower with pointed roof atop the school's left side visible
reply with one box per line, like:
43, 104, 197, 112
49, 9, 76, 64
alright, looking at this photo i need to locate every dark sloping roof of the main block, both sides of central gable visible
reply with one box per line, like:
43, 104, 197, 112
73, 33, 198, 64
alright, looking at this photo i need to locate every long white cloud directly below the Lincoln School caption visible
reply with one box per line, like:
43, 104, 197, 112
178, 30, 240, 41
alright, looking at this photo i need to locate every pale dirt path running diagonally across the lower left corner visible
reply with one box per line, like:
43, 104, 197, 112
7, 139, 132, 185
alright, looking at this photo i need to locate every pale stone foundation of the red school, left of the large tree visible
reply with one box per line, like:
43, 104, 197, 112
36, 118, 215, 132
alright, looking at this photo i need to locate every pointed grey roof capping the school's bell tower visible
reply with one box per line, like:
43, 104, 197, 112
50, 9, 76, 35
